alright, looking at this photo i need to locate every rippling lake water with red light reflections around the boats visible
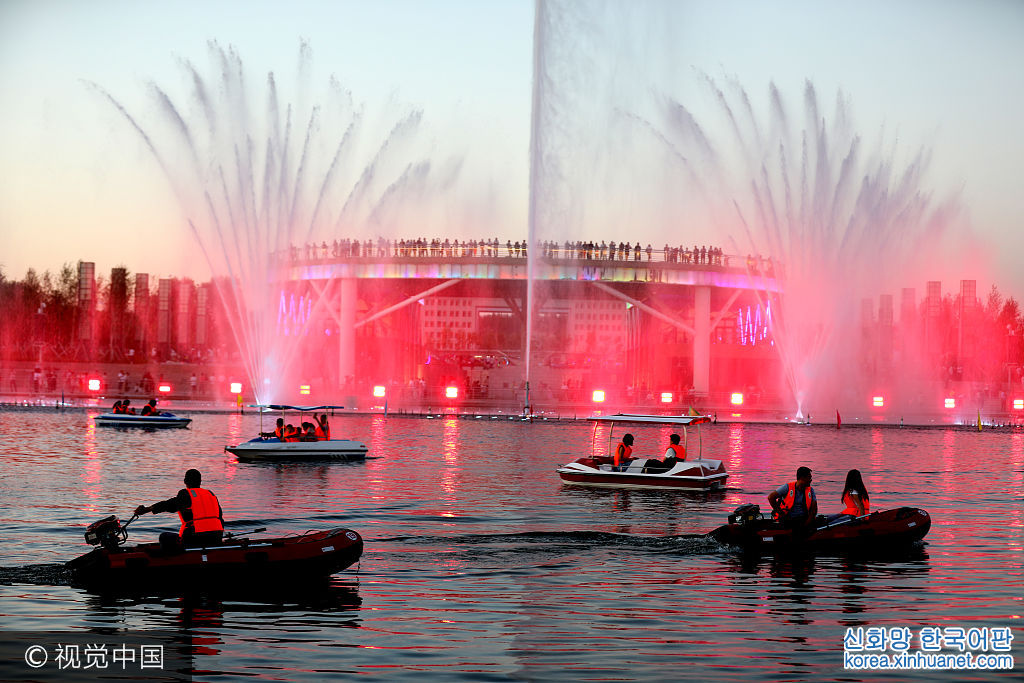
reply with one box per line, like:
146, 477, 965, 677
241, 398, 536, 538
0, 412, 1024, 681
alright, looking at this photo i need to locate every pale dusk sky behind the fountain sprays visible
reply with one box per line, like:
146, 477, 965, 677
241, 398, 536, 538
0, 0, 1024, 299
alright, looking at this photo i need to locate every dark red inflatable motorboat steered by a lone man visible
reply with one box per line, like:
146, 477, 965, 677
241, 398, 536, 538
68, 516, 362, 588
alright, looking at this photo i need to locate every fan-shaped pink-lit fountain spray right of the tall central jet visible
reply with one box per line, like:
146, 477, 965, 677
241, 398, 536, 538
652, 75, 957, 414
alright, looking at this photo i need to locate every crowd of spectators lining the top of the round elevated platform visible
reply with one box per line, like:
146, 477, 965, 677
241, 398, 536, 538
289, 238, 771, 270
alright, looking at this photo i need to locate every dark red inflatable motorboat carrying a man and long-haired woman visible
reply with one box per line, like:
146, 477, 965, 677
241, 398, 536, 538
708, 504, 932, 552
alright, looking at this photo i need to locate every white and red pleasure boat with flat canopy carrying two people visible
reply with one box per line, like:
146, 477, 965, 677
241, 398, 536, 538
557, 414, 729, 490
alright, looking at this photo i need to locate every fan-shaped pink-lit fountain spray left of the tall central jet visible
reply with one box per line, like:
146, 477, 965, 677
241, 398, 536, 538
93, 42, 459, 402
